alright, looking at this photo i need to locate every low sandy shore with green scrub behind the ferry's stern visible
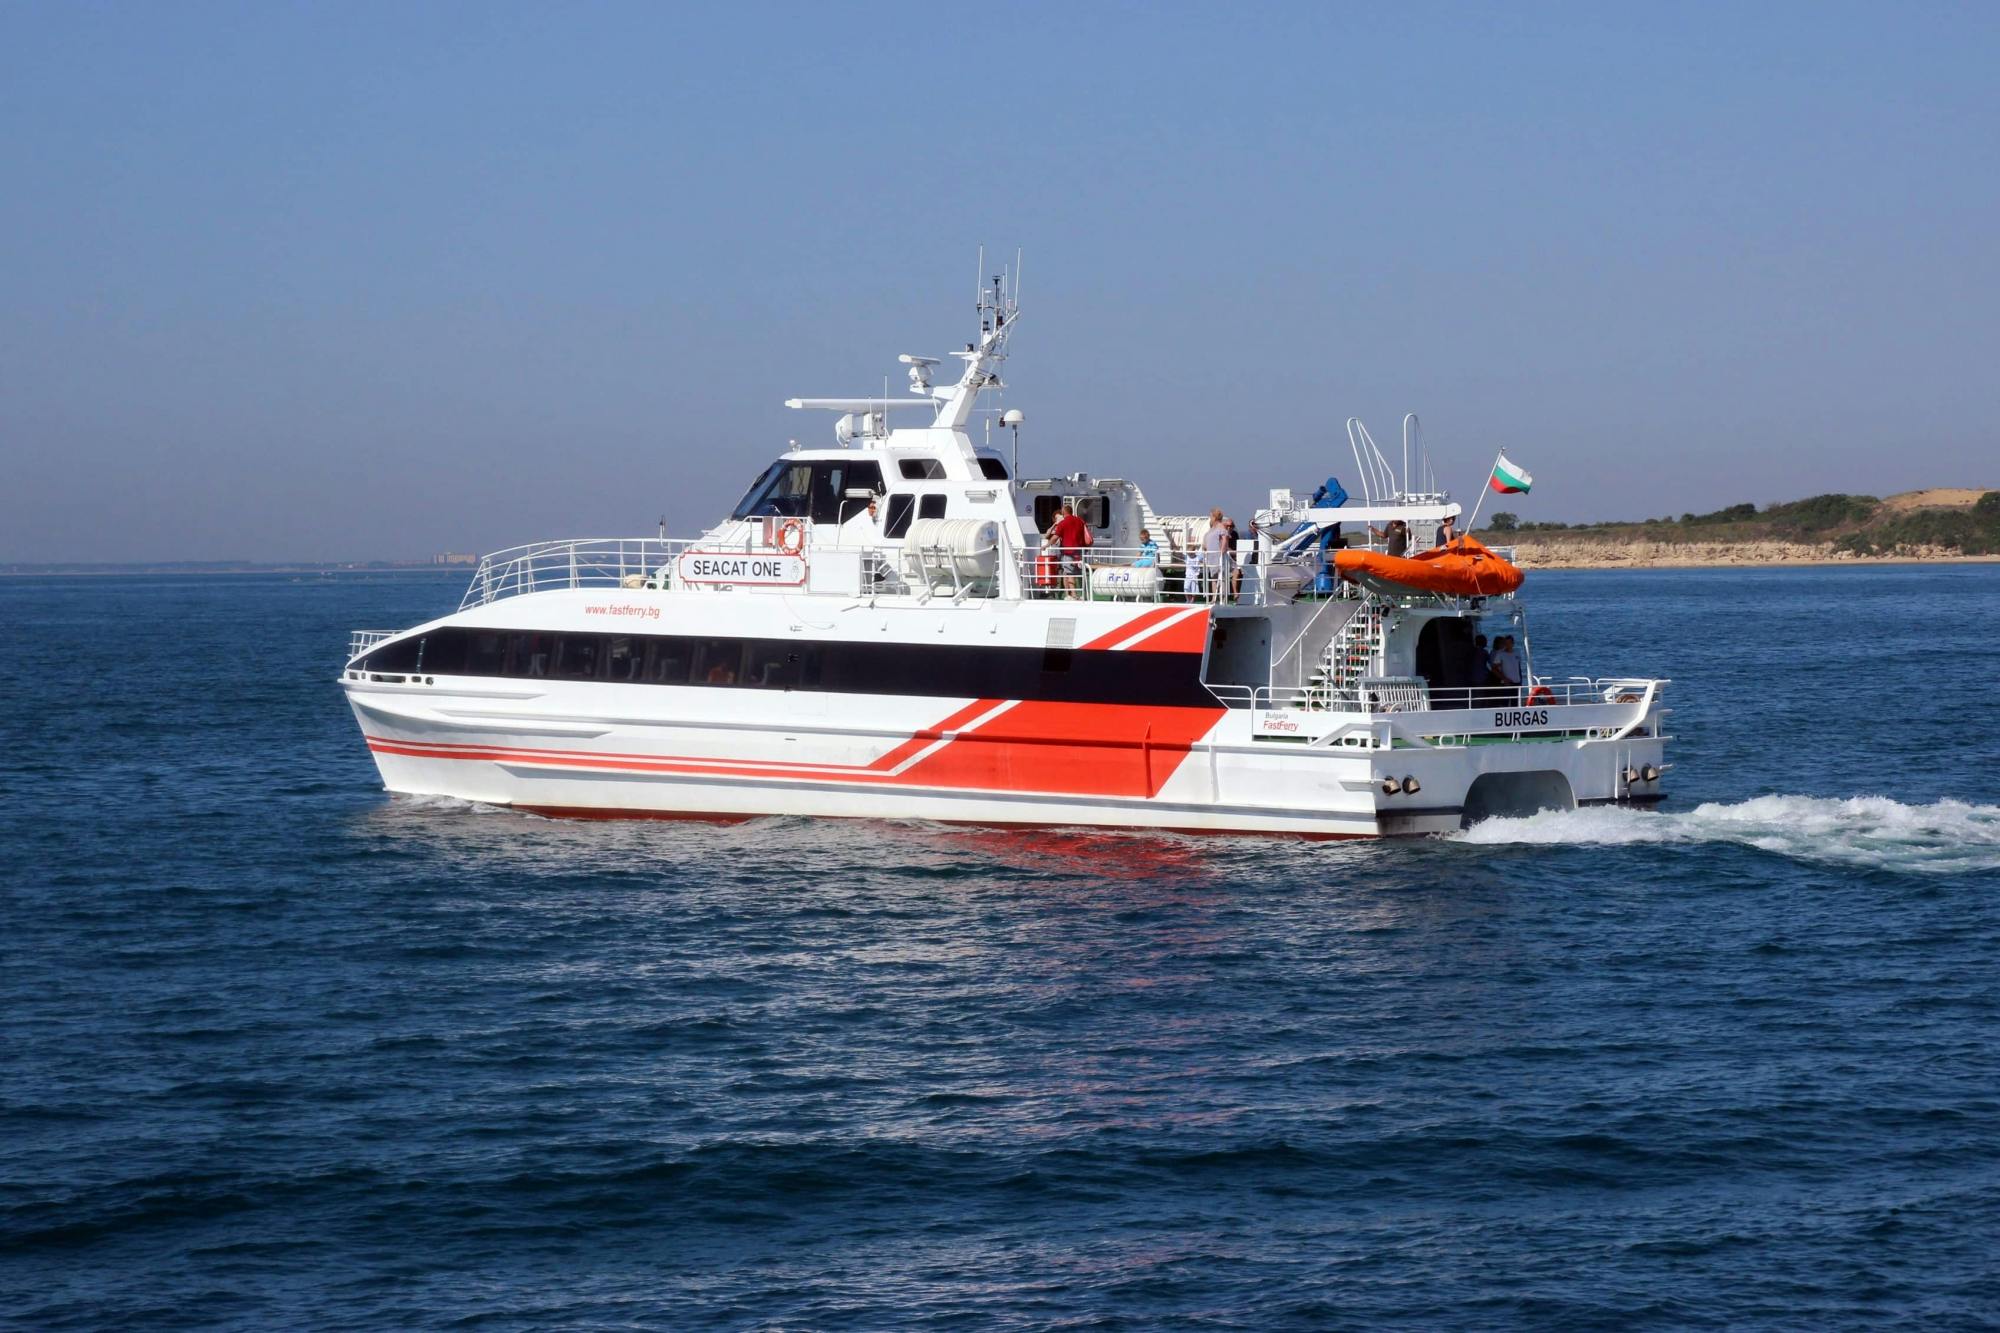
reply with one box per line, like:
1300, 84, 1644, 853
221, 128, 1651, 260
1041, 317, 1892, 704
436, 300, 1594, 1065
1486, 490, 2000, 556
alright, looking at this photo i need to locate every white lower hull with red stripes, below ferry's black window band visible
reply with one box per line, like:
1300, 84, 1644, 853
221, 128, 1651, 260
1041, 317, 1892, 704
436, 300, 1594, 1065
348, 681, 1662, 839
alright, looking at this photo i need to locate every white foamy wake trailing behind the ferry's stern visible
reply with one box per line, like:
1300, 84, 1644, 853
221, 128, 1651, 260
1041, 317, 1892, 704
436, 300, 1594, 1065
1454, 797, 2000, 875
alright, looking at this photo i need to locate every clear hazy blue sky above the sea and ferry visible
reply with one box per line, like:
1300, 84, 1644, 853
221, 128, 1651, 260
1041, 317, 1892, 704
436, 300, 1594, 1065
0, 2, 2000, 560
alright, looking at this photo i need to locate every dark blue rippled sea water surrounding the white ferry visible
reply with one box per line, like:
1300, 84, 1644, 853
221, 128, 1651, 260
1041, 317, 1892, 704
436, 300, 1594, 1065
0, 566, 2000, 1329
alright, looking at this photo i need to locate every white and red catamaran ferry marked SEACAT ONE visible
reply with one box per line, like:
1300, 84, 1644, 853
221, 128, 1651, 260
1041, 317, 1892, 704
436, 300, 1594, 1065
340, 278, 1668, 839
